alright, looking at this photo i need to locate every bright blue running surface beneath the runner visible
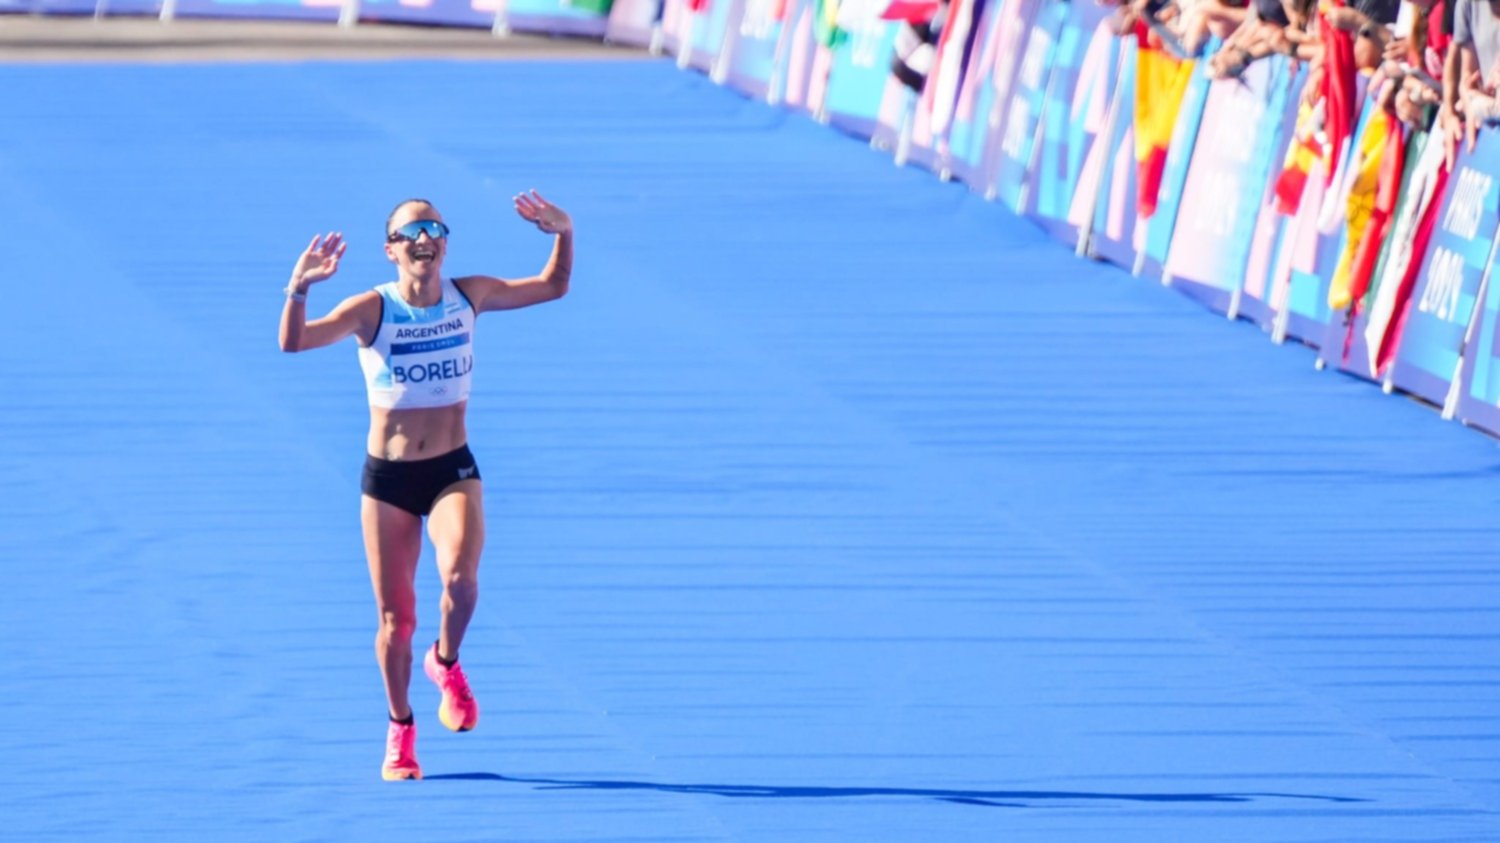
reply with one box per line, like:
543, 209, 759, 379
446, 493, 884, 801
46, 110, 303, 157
0, 55, 1500, 843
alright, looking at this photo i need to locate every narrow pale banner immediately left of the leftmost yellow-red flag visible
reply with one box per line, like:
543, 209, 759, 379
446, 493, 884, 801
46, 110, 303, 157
1089, 38, 1146, 269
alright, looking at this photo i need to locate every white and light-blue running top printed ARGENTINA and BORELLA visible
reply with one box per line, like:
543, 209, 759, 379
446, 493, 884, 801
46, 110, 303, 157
360, 278, 476, 410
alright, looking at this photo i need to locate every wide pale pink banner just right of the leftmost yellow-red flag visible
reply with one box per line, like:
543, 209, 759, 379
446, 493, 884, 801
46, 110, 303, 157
1163, 56, 1292, 314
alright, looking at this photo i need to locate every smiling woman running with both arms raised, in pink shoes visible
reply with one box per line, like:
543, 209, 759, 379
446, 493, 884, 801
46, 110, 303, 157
281, 191, 573, 780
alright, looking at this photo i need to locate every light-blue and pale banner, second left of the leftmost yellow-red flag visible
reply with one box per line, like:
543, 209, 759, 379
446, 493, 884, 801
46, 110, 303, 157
1029, 3, 1121, 245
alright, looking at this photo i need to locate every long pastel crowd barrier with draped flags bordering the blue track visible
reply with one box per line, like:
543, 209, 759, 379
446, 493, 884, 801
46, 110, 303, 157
17, 0, 1500, 434
